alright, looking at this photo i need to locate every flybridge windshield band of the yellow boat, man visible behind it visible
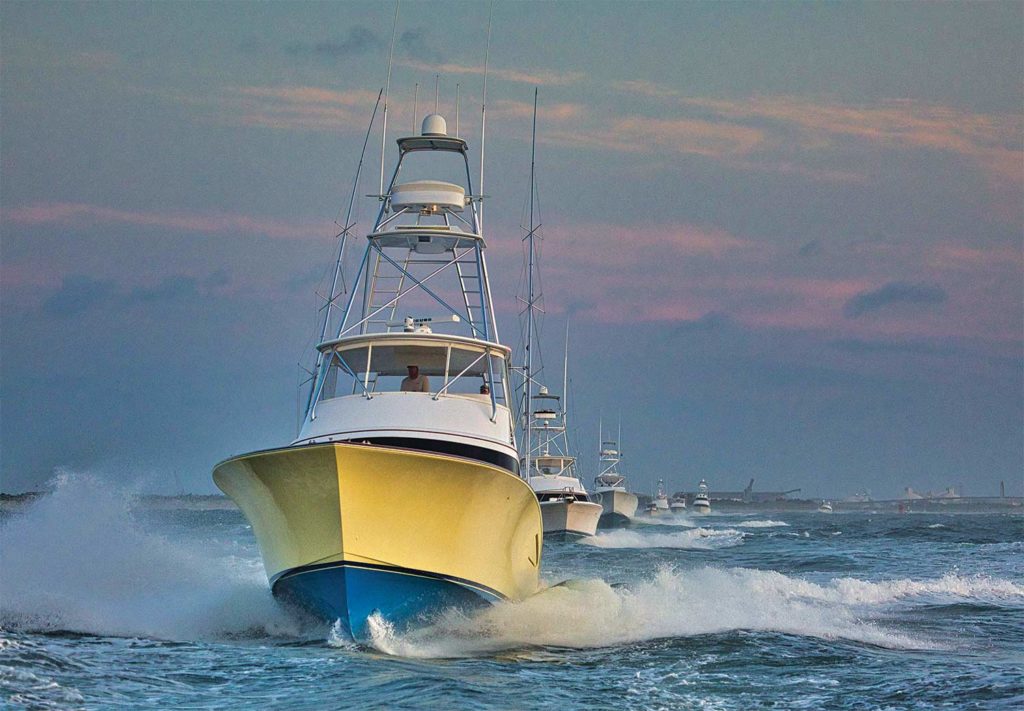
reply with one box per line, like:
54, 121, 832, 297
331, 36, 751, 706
319, 338, 509, 405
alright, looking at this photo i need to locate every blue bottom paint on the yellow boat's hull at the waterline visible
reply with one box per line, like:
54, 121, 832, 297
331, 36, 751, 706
273, 564, 497, 640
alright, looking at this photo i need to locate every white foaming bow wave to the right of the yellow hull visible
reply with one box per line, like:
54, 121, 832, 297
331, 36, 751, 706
371, 568, 936, 657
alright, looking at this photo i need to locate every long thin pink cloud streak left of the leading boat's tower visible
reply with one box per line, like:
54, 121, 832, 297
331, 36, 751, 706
2, 203, 329, 239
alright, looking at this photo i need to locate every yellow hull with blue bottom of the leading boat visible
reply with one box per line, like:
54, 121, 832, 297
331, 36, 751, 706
213, 443, 543, 637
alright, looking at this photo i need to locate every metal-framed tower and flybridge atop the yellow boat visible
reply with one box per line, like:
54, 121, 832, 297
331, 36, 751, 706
306, 114, 512, 428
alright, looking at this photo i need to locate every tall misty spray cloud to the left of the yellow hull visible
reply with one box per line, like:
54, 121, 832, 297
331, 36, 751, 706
0, 473, 298, 639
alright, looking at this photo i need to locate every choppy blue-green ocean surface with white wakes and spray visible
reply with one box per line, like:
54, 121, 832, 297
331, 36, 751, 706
0, 476, 1024, 710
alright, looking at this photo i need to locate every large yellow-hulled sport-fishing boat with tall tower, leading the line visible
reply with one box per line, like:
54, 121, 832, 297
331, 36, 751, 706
213, 110, 543, 639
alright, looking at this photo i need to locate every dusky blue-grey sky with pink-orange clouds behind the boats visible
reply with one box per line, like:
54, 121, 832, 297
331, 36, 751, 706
0, 0, 1024, 498
